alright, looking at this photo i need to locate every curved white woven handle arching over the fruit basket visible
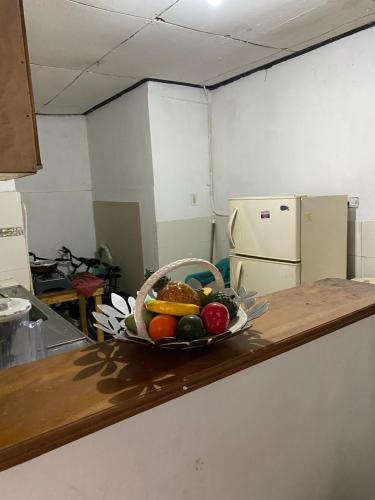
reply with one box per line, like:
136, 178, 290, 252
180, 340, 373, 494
134, 258, 224, 342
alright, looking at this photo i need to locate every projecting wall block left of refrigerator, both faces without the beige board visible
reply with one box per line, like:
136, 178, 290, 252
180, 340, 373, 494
88, 82, 214, 284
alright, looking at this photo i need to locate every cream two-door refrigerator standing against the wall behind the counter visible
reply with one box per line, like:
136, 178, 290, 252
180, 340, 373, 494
228, 195, 348, 295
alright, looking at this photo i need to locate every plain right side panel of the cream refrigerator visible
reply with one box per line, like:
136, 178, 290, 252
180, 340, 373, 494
301, 195, 348, 283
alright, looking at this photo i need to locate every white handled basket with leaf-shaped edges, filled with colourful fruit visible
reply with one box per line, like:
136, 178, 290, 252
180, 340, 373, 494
93, 258, 269, 350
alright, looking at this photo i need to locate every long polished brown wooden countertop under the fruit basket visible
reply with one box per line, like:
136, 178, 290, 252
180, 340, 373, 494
0, 279, 375, 470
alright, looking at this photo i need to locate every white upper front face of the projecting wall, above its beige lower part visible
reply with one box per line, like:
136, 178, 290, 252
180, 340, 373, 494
148, 82, 211, 222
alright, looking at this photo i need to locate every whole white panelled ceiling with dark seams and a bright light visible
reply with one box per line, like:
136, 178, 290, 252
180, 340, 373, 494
24, 0, 375, 114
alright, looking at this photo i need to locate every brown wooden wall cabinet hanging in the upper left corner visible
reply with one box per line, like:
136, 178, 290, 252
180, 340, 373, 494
0, 0, 41, 180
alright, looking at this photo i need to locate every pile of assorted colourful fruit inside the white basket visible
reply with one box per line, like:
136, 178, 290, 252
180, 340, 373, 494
129, 270, 238, 341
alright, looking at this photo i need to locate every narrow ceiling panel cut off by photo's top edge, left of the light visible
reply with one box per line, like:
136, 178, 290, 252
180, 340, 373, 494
70, 0, 174, 18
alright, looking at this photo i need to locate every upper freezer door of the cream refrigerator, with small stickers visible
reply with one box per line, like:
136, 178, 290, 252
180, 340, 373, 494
228, 197, 301, 262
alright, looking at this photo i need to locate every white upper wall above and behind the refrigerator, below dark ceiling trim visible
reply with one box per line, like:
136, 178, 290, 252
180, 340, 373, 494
213, 29, 375, 219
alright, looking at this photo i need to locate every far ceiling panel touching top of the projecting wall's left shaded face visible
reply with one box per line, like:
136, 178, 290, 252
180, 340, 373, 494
46, 72, 137, 111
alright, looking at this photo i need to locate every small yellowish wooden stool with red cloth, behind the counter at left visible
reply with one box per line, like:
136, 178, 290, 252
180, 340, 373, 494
38, 287, 104, 342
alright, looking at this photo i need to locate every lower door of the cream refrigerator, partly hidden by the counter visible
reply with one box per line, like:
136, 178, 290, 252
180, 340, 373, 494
230, 256, 301, 295
